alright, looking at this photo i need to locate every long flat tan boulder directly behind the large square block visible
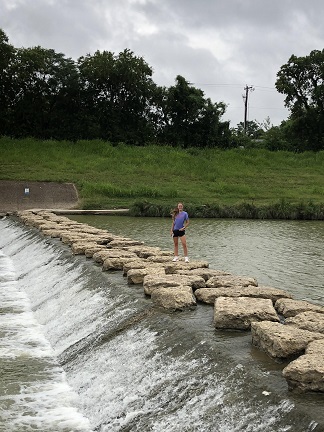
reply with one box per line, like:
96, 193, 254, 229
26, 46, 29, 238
195, 285, 291, 304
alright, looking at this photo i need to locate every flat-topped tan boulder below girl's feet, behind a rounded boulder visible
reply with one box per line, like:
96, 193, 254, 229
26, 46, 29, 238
143, 274, 205, 295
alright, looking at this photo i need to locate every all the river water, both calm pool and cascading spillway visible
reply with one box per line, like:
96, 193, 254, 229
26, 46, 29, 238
0, 216, 324, 432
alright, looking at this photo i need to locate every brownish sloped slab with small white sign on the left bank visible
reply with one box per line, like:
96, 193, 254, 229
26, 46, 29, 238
0, 180, 79, 213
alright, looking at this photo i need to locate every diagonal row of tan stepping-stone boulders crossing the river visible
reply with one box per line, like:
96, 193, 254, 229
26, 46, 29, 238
13, 210, 324, 392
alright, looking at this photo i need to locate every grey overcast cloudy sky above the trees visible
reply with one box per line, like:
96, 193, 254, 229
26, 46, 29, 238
0, 0, 324, 127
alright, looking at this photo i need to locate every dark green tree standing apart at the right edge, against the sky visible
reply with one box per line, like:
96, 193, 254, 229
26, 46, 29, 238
276, 50, 324, 150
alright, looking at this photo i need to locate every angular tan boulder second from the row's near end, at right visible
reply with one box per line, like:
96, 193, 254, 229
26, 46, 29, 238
251, 321, 323, 359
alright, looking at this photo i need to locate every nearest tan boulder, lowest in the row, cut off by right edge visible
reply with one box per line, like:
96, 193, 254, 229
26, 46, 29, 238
282, 339, 324, 393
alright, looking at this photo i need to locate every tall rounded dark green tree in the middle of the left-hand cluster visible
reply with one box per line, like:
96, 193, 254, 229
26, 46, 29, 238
78, 49, 156, 144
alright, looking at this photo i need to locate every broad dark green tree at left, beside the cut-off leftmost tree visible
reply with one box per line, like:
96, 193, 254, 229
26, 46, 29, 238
9, 46, 80, 139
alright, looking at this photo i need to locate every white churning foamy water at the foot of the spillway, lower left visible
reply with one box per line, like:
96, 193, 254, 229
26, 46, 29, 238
0, 245, 90, 432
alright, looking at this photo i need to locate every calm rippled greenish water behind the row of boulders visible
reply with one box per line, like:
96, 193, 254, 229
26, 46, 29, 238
71, 215, 324, 305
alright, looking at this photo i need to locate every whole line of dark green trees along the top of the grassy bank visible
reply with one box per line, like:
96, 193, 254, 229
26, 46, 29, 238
0, 29, 324, 151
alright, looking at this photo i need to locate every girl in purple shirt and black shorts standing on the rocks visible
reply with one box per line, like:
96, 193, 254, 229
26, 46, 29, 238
171, 203, 189, 262
